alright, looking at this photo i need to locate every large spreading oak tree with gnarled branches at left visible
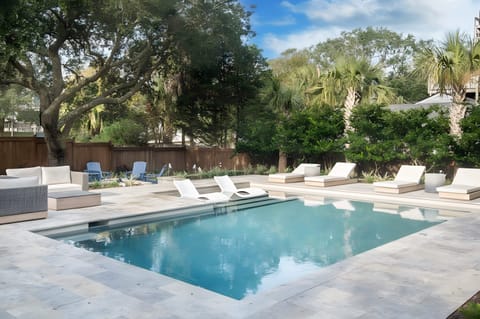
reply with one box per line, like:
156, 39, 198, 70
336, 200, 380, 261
0, 0, 181, 165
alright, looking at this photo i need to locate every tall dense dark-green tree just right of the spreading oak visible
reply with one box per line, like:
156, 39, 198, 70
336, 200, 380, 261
175, 1, 265, 146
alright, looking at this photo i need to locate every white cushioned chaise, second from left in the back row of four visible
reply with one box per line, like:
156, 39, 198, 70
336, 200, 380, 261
305, 162, 357, 187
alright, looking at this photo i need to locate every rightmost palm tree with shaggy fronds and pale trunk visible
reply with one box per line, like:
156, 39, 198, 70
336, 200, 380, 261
415, 31, 480, 137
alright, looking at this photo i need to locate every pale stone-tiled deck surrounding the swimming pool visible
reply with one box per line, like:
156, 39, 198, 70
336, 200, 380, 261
0, 176, 480, 319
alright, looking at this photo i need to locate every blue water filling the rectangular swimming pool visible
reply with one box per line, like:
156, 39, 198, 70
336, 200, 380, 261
57, 200, 441, 299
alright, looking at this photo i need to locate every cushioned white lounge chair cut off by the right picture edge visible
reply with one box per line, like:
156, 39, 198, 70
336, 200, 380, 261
437, 168, 480, 200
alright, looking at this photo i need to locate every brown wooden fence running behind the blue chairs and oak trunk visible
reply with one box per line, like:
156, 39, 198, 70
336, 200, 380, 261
0, 137, 250, 174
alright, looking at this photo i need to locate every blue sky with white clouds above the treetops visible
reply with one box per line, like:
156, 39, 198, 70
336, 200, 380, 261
240, 0, 480, 59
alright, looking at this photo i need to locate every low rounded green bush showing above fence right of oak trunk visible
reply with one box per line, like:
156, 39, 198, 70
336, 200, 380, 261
92, 119, 148, 146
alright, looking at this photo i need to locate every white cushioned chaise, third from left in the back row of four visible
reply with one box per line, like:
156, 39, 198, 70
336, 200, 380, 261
373, 165, 425, 194
